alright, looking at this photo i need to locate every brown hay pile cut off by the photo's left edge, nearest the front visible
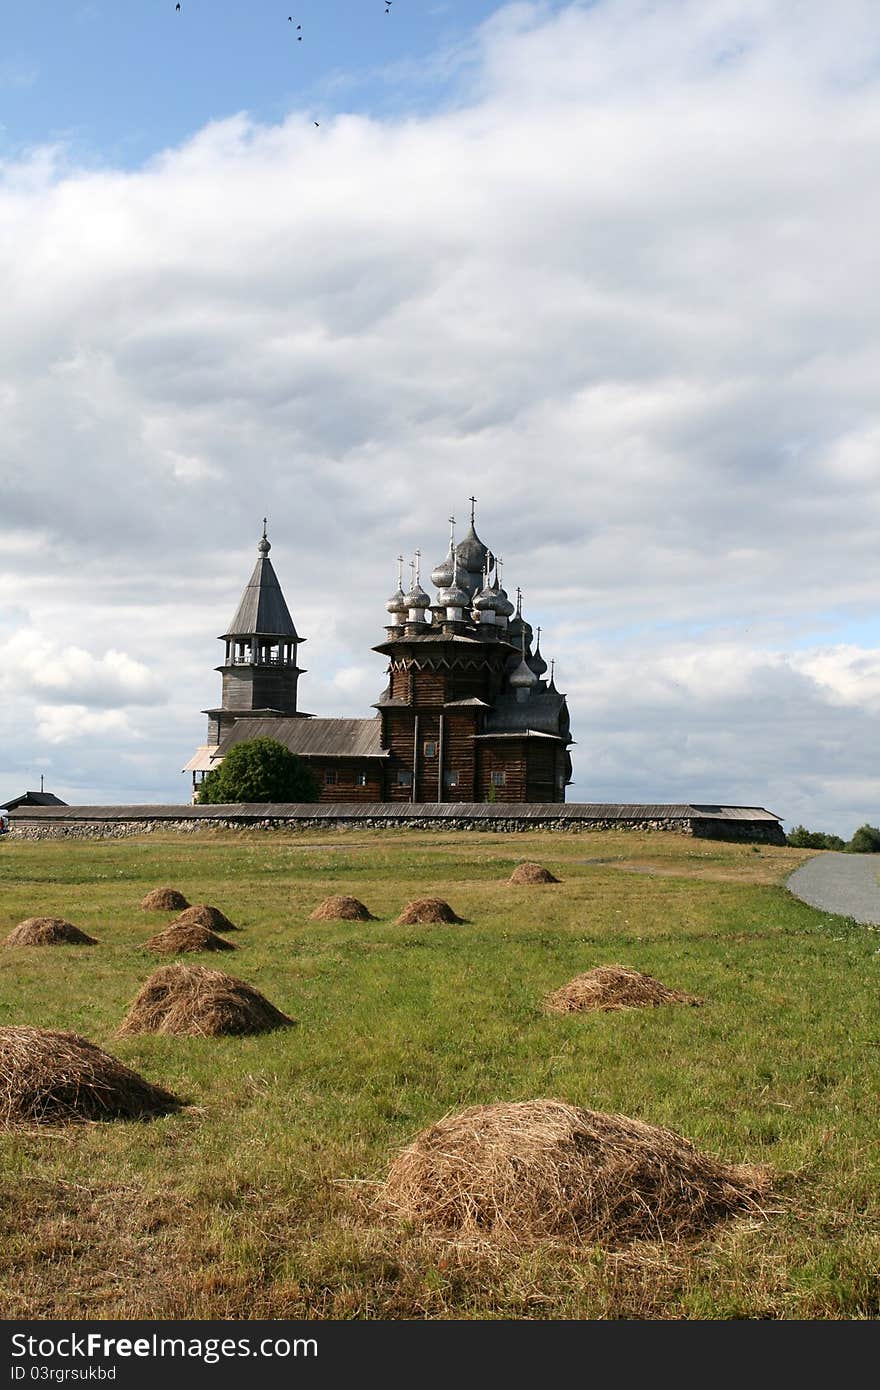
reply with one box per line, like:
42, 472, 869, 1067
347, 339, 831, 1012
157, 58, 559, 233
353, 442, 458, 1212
0, 1027, 182, 1125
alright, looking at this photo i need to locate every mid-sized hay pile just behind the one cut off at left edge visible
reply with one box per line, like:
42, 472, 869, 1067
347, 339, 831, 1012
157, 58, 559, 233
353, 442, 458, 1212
120, 962, 293, 1037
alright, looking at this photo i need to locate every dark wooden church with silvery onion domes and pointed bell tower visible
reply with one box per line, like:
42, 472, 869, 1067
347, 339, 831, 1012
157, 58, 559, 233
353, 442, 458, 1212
184, 498, 571, 802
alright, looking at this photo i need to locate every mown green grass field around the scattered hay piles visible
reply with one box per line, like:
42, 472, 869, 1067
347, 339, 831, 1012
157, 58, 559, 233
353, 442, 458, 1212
0, 831, 880, 1319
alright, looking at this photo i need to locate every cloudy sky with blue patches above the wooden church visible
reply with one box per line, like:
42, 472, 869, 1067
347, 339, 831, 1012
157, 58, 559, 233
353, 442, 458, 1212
0, 0, 880, 837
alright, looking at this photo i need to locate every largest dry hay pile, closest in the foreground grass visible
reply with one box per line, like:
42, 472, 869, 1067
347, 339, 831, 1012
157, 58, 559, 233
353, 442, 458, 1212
381, 1101, 769, 1245
